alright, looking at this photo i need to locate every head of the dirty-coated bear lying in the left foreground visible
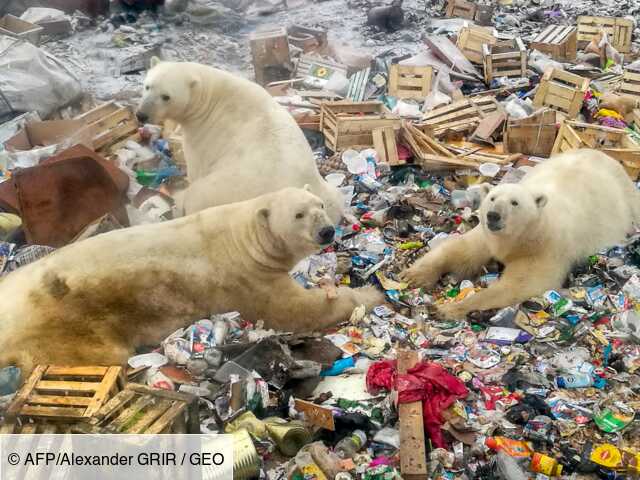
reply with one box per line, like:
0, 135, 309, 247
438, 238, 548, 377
257, 186, 336, 259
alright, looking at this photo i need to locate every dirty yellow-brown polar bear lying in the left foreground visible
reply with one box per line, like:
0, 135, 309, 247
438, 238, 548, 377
0, 188, 384, 372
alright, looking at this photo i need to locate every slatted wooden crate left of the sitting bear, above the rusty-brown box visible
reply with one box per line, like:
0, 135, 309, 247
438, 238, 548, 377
75, 101, 139, 151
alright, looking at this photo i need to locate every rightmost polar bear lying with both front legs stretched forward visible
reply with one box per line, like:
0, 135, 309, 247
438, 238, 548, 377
402, 150, 640, 319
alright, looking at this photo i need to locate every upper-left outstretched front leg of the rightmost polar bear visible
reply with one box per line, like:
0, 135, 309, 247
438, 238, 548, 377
402, 226, 491, 288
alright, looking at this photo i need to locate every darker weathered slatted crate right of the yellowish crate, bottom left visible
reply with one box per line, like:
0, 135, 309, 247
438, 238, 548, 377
73, 383, 200, 434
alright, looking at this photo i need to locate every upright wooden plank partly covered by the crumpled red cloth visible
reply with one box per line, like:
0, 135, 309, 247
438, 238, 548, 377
398, 350, 427, 480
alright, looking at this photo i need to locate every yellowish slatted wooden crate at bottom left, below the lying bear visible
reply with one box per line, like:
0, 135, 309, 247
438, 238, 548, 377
7, 365, 125, 422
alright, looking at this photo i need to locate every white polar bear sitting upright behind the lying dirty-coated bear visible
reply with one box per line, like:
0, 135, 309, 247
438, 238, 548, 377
137, 59, 343, 223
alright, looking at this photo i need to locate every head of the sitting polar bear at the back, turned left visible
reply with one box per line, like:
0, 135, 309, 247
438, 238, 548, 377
136, 57, 200, 124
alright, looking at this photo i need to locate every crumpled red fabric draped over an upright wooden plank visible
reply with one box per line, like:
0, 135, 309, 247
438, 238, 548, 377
367, 360, 469, 448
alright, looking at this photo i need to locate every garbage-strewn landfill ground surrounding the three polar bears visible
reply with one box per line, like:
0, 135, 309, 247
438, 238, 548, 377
0, 0, 640, 480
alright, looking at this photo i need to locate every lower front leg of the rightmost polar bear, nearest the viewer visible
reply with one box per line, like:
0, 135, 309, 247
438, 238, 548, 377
438, 258, 567, 320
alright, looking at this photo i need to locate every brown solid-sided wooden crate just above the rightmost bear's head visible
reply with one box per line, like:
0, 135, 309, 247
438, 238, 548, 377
504, 109, 558, 157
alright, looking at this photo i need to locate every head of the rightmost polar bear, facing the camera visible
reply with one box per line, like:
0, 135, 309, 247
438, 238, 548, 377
480, 184, 547, 238
